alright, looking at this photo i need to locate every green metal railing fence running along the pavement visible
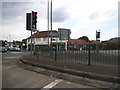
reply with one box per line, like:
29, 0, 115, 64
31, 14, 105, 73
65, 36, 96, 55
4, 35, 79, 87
36, 45, 120, 68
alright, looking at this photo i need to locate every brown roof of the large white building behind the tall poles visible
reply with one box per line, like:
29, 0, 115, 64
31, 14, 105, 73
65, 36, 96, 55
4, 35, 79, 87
27, 30, 58, 39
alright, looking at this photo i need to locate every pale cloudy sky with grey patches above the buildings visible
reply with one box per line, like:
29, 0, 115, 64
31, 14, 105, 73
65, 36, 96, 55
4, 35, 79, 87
0, 0, 120, 41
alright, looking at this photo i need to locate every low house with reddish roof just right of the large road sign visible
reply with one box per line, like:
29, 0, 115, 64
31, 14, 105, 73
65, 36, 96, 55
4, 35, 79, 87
68, 39, 88, 50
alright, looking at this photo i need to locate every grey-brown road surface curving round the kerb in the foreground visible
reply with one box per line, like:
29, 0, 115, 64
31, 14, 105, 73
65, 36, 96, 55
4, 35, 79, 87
2, 52, 93, 90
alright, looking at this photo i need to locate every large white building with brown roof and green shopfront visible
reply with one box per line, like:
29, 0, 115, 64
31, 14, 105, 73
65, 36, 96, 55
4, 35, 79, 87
27, 30, 68, 50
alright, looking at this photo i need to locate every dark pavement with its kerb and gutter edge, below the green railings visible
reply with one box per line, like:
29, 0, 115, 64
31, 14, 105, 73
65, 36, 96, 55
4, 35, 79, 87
19, 55, 120, 88
